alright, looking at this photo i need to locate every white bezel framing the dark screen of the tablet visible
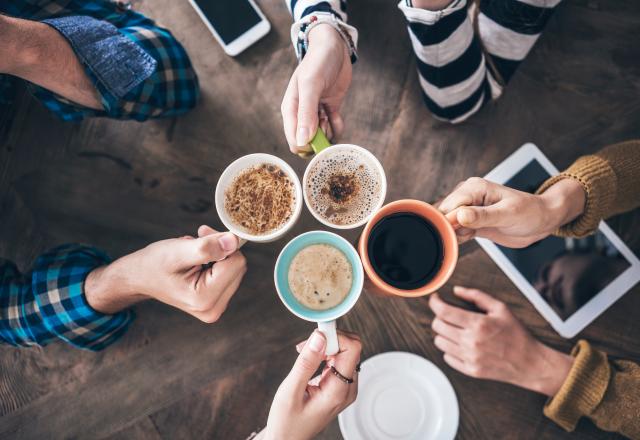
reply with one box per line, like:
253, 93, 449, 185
476, 143, 640, 338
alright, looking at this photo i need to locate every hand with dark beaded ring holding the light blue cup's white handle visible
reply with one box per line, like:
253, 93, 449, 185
258, 330, 362, 440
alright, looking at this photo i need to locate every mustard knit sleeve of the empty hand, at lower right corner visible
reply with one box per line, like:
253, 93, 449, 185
544, 340, 640, 439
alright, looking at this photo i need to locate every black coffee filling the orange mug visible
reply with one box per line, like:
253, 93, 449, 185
367, 212, 443, 290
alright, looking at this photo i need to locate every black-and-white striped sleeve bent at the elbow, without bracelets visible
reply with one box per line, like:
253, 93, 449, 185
398, 0, 559, 123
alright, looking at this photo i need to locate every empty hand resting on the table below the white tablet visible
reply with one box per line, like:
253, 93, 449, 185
429, 286, 573, 396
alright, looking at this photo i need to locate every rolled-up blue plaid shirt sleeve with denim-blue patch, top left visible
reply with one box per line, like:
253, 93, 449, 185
0, 0, 199, 121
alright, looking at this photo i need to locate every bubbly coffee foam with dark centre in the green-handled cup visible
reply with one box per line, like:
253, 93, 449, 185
305, 150, 382, 225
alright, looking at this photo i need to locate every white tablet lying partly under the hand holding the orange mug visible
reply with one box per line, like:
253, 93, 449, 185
476, 144, 640, 338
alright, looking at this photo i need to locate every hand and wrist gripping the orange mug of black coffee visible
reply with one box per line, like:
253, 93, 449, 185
438, 177, 586, 248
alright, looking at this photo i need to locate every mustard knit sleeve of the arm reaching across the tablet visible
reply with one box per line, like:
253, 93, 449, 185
537, 140, 640, 237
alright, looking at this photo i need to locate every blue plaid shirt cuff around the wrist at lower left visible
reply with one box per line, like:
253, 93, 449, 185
31, 245, 134, 351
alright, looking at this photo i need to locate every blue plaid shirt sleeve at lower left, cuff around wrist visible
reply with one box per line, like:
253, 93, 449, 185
0, 245, 134, 350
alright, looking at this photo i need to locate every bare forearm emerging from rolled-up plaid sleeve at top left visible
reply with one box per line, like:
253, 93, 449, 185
0, 16, 102, 109
